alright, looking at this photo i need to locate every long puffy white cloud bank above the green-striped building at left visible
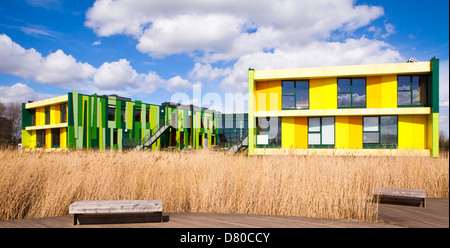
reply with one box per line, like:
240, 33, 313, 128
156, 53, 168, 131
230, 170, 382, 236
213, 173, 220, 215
0, 34, 197, 98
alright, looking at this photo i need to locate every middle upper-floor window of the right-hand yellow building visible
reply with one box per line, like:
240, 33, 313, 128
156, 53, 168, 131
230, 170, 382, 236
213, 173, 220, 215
338, 78, 366, 108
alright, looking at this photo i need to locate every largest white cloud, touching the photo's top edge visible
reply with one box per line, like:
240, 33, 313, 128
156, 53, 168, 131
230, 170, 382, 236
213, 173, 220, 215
85, 0, 384, 60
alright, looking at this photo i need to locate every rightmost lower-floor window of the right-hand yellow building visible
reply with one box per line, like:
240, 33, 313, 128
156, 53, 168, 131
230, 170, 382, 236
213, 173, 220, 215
363, 116, 398, 148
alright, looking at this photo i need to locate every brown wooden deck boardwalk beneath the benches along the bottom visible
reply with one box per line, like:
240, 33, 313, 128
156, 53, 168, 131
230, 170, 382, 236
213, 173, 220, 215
0, 198, 449, 228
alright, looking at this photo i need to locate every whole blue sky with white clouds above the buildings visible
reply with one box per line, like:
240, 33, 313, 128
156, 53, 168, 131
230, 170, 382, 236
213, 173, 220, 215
0, 0, 449, 133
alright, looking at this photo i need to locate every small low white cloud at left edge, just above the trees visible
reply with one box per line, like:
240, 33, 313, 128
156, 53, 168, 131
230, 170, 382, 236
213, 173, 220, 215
0, 83, 54, 103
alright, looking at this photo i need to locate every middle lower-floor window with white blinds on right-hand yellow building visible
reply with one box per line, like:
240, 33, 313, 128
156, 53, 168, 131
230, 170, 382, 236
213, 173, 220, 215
308, 117, 334, 148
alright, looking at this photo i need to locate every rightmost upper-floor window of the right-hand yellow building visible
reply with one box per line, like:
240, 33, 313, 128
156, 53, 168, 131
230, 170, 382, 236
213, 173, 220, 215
397, 75, 427, 106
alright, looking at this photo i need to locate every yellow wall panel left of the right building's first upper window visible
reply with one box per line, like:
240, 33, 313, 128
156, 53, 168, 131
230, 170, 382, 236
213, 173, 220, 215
255, 81, 281, 111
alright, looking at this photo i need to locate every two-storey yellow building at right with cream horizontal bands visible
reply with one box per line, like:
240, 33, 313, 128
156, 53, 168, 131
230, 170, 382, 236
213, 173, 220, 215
249, 58, 439, 156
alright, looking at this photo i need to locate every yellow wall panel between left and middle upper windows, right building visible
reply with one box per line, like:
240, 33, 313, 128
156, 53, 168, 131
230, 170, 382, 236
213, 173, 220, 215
309, 78, 337, 109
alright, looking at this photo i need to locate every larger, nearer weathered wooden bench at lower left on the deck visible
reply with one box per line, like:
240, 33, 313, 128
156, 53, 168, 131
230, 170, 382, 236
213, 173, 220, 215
69, 199, 163, 225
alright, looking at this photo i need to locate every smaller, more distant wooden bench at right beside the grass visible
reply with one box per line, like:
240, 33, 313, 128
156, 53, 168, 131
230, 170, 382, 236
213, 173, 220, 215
372, 187, 426, 207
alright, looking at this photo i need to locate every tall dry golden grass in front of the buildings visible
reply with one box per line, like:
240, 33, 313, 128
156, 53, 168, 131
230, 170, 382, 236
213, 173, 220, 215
0, 150, 449, 220
